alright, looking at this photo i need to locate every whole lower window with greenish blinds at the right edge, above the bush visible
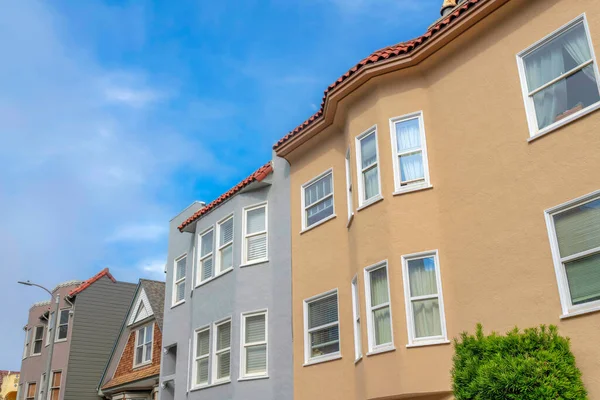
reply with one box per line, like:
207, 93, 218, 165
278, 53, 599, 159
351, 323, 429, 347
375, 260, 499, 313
545, 191, 600, 316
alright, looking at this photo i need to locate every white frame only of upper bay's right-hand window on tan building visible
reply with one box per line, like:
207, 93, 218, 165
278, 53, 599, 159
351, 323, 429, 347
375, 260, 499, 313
390, 111, 431, 195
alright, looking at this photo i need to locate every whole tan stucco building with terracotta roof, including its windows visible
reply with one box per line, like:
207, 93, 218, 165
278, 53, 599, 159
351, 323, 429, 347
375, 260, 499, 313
275, 0, 600, 400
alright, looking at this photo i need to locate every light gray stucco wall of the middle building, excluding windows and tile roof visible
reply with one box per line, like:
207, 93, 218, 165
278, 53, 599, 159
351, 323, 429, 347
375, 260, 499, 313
160, 158, 293, 400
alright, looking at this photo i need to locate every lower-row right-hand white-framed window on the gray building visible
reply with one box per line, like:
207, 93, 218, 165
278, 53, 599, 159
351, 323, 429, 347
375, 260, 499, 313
240, 310, 268, 379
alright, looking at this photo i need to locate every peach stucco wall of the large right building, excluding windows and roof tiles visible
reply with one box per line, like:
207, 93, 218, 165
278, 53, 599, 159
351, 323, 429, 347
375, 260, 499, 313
288, 0, 600, 400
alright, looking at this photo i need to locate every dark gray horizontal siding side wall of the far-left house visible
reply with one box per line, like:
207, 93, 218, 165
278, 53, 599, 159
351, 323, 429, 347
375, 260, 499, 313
64, 277, 137, 400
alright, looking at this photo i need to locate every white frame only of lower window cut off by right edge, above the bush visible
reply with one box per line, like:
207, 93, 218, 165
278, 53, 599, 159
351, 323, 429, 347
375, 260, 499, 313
544, 190, 600, 318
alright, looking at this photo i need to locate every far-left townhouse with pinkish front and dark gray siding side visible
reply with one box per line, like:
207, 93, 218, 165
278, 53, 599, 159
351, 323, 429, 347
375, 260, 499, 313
18, 269, 136, 400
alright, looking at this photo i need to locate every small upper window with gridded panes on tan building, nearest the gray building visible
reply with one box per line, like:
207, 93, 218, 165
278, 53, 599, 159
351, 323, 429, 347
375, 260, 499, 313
302, 170, 334, 229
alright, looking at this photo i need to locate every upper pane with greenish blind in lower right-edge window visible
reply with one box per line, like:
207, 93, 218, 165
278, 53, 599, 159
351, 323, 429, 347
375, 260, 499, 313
554, 199, 600, 257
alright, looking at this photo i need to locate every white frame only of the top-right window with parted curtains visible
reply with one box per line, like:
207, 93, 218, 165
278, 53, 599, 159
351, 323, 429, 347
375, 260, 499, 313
517, 13, 600, 141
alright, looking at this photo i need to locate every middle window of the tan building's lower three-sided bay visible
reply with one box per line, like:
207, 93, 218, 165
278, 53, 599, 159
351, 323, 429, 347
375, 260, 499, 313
365, 261, 394, 353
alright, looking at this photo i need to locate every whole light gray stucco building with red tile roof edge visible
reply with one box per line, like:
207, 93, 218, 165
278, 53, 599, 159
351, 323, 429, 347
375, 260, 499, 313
159, 158, 293, 400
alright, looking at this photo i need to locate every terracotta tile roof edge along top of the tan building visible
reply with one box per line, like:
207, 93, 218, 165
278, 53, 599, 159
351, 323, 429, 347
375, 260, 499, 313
273, 0, 487, 150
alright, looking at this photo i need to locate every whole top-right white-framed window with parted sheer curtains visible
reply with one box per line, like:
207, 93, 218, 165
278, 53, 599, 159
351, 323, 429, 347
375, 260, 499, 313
517, 14, 600, 137
